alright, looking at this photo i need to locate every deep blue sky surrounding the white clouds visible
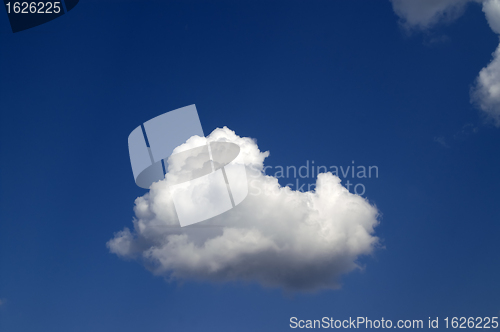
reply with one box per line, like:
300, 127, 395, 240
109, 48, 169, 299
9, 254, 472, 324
0, 0, 500, 332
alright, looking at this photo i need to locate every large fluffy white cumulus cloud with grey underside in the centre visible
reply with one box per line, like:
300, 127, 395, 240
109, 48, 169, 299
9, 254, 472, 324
107, 127, 379, 291
